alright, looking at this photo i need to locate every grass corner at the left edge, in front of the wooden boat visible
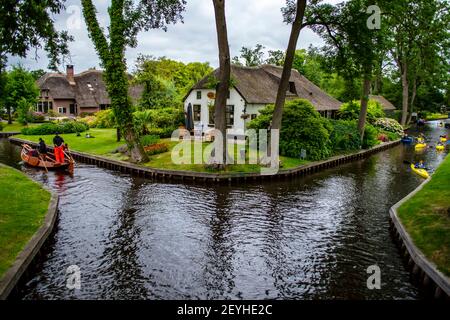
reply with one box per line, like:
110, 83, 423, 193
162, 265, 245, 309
0, 165, 51, 278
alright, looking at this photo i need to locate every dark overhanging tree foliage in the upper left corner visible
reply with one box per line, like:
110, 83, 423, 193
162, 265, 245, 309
0, 0, 72, 123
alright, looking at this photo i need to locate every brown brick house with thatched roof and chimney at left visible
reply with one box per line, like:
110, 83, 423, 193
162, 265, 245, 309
37, 65, 143, 116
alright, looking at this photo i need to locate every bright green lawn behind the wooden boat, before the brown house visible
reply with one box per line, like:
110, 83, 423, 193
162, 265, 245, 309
15, 129, 124, 155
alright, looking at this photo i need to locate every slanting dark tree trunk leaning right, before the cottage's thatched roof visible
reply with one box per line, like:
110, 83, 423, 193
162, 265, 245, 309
269, 0, 306, 132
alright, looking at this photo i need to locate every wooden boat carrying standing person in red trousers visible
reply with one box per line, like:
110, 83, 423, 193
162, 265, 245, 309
20, 144, 75, 173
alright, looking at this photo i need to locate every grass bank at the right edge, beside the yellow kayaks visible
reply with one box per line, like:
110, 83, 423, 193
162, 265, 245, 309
398, 156, 450, 276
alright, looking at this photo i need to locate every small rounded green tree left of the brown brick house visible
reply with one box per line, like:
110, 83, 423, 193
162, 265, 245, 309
5, 65, 39, 124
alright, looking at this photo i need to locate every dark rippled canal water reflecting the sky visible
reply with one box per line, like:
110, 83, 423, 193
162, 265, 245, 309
0, 122, 450, 299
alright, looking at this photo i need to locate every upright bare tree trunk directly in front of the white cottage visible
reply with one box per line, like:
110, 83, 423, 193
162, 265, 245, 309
213, 0, 231, 165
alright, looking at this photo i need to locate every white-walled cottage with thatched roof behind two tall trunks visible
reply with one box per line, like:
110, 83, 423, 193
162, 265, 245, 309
184, 65, 342, 134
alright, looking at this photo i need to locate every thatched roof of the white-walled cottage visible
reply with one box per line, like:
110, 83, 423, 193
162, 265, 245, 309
188, 65, 342, 111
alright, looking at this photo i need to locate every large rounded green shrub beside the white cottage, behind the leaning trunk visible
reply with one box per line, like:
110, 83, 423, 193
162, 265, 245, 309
248, 99, 333, 160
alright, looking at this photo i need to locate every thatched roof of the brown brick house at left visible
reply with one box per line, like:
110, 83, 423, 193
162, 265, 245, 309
37, 70, 143, 108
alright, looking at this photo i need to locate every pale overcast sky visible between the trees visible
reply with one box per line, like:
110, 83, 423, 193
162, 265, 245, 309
8, 0, 340, 73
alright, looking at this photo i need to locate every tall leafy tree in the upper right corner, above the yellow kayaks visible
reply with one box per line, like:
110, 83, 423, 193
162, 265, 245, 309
379, 0, 450, 125
